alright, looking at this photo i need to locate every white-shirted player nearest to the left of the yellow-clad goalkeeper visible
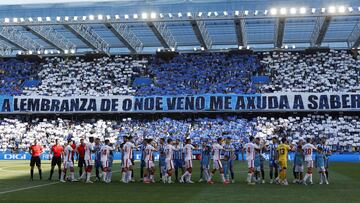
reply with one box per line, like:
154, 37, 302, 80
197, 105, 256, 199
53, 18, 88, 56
243, 136, 260, 185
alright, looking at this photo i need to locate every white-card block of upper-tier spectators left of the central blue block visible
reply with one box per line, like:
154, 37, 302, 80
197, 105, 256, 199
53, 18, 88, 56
24, 56, 147, 96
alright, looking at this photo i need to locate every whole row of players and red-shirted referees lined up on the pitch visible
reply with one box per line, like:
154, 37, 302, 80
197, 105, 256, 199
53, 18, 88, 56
30, 136, 331, 185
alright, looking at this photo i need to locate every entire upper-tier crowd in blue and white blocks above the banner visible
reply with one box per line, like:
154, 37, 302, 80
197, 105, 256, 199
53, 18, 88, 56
0, 50, 360, 96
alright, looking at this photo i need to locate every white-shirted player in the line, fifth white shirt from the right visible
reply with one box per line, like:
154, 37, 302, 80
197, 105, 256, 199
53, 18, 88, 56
162, 138, 178, 183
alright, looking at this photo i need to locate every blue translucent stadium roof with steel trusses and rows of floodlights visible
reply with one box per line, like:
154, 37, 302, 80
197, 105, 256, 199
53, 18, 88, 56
0, 0, 360, 55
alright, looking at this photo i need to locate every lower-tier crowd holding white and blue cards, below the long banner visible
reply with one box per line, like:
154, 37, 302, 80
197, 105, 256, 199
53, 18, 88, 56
0, 115, 360, 152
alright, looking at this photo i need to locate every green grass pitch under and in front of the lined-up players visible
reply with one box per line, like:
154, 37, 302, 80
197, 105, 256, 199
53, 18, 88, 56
0, 161, 360, 203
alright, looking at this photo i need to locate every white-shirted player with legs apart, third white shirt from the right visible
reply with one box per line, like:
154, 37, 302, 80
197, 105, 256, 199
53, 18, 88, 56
208, 137, 229, 184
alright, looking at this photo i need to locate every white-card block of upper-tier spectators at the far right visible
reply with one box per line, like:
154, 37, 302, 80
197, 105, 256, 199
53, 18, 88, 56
261, 50, 360, 92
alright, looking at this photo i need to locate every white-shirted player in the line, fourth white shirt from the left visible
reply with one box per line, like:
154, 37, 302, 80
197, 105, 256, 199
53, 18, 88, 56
121, 137, 136, 183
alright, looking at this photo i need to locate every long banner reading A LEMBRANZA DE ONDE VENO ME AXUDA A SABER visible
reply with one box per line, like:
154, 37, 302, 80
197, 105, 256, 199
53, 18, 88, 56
0, 92, 360, 114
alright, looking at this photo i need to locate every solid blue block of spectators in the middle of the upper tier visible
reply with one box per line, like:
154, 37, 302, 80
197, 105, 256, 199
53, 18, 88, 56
137, 53, 259, 95
